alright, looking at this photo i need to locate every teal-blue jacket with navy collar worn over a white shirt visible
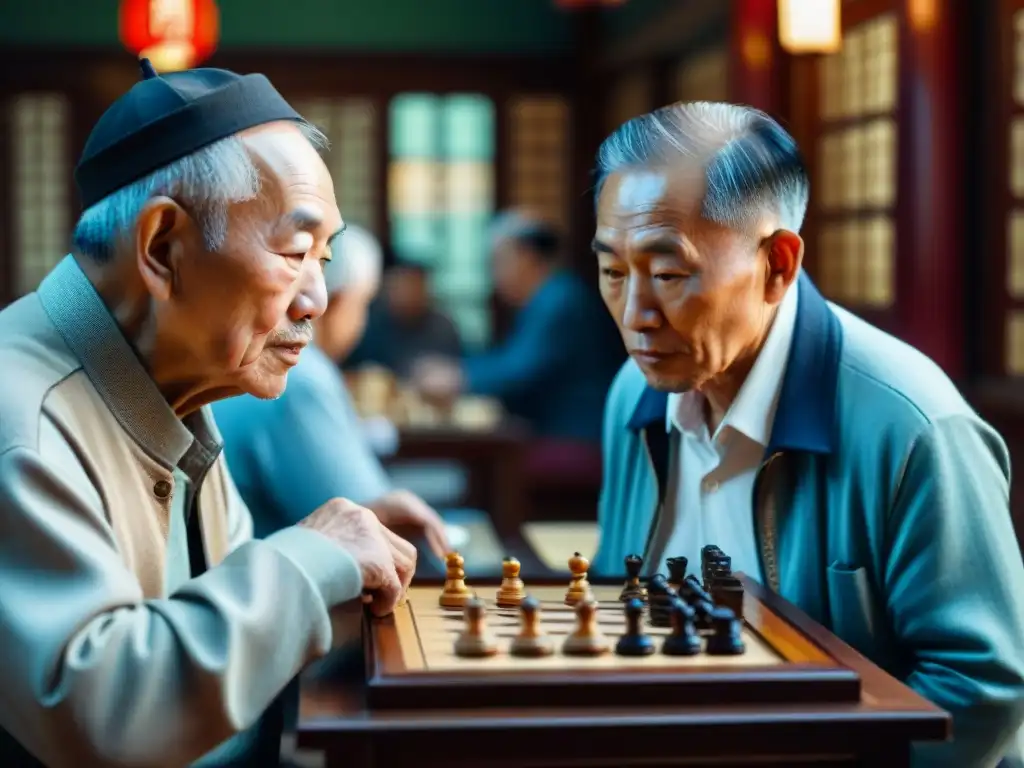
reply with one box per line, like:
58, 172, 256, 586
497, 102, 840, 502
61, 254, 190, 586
593, 276, 1024, 768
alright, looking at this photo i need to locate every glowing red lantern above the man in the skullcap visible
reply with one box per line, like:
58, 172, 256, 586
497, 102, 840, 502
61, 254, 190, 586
119, 0, 220, 72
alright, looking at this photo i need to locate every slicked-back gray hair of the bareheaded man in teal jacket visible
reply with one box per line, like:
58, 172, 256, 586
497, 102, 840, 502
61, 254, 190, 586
596, 101, 810, 232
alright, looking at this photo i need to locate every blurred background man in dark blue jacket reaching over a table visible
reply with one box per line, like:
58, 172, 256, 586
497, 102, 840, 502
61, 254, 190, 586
414, 211, 623, 456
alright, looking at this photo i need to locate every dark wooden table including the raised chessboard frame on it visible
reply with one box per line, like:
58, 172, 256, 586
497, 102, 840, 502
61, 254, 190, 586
298, 581, 949, 768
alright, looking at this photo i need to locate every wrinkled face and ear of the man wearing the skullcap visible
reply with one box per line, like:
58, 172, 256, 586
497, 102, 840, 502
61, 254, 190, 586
138, 123, 343, 398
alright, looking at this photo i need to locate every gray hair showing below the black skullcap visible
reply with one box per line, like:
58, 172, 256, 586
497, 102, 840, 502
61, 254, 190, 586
72, 123, 328, 263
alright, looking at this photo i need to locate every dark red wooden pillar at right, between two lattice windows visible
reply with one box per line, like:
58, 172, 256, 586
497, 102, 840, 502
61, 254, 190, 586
896, 0, 962, 379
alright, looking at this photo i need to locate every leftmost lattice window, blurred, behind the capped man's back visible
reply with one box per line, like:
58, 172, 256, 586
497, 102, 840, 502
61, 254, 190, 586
9, 93, 72, 295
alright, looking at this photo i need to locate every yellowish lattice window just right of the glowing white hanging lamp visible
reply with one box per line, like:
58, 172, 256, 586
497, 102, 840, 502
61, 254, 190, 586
816, 13, 898, 308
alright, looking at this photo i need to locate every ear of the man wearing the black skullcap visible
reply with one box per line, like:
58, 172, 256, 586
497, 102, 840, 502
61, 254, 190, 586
135, 197, 197, 301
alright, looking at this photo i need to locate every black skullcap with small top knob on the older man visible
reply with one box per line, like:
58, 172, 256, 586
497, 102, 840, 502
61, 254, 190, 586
75, 58, 302, 208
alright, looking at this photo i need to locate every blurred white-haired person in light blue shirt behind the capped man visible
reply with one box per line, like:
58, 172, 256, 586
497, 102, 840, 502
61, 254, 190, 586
213, 225, 450, 559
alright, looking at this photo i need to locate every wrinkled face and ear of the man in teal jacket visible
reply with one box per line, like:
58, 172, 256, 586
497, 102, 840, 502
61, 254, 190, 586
594, 169, 801, 392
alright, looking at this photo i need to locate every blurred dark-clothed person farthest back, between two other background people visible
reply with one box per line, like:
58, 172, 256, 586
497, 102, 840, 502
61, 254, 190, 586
345, 249, 462, 380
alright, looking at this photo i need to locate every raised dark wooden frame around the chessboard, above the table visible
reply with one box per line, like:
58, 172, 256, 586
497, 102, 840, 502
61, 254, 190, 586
364, 574, 861, 711
